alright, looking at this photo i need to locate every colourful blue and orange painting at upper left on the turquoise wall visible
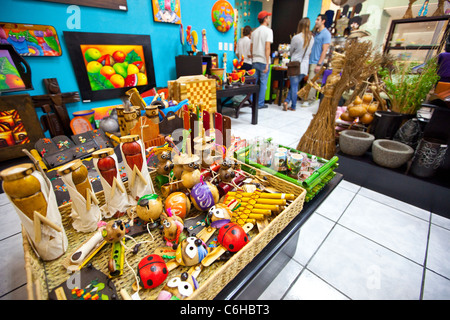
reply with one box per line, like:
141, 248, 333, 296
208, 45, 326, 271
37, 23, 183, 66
0, 22, 62, 57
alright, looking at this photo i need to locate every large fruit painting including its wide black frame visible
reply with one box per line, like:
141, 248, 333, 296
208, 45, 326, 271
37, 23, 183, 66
64, 31, 156, 102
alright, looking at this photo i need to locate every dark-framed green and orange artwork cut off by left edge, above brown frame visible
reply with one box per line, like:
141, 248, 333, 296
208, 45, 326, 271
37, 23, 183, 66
0, 44, 33, 94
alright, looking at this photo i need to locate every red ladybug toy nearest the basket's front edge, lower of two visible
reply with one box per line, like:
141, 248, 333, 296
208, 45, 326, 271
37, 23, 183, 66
138, 254, 169, 289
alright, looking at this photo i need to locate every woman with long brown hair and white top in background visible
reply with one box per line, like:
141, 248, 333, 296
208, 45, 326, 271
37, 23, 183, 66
283, 18, 314, 111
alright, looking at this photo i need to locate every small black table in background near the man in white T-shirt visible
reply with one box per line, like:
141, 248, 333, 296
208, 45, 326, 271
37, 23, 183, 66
216, 84, 259, 124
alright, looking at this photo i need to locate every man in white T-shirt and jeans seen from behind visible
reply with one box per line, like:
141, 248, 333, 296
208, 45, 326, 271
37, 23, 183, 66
251, 11, 273, 109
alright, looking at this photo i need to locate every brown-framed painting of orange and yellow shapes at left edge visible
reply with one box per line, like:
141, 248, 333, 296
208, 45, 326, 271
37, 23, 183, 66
0, 94, 44, 161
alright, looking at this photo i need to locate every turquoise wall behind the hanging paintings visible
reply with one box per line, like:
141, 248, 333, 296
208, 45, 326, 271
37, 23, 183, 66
0, 0, 235, 122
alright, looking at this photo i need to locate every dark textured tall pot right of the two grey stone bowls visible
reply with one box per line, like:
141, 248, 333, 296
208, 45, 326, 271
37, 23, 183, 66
411, 138, 448, 178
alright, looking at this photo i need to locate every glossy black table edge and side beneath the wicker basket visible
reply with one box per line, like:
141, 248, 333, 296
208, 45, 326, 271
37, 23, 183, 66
215, 173, 343, 300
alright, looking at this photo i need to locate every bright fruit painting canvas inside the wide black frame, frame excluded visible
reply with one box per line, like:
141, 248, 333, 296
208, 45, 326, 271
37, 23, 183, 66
80, 45, 148, 91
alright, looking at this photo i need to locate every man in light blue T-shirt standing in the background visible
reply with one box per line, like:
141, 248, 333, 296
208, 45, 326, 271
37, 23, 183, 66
302, 14, 331, 107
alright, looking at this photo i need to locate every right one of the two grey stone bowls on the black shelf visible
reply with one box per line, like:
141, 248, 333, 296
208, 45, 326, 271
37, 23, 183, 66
372, 139, 414, 168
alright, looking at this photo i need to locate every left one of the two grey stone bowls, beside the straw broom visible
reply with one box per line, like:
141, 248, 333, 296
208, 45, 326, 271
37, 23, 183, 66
339, 130, 375, 157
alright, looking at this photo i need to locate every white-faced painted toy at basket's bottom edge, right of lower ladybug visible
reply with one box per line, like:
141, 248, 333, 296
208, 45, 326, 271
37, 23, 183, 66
157, 265, 202, 300
